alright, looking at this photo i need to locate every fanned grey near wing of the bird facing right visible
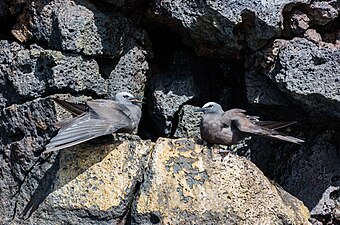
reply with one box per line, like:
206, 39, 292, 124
45, 100, 132, 153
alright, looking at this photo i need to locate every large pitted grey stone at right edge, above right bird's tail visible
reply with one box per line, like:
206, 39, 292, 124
245, 37, 340, 117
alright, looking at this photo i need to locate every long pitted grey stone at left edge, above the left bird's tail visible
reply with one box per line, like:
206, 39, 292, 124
0, 41, 107, 104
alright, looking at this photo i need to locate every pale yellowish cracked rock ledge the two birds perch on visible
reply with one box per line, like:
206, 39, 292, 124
7, 136, 309, 224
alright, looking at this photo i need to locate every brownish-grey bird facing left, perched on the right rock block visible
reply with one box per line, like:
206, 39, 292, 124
196, 102, 304, 146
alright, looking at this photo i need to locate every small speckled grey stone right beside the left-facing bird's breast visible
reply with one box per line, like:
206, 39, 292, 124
174, 105, 201, 138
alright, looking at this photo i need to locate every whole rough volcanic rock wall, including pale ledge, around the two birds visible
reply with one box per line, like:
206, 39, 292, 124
0, 0, 340, 224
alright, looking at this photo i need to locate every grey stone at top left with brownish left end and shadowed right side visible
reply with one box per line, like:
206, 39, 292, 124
12, 0, 130, 56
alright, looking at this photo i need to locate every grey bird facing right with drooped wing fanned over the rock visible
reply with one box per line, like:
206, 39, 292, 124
43, 92, 143, 154
